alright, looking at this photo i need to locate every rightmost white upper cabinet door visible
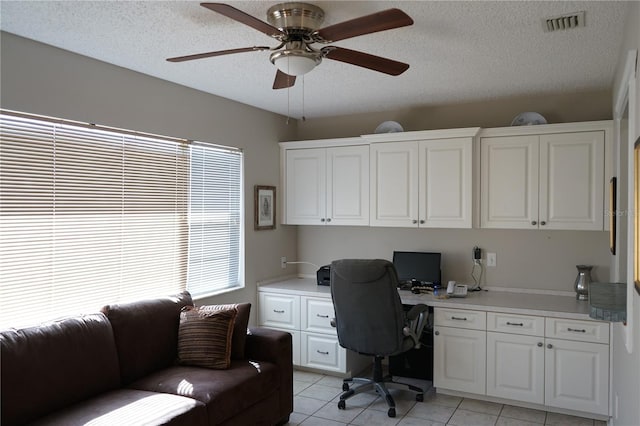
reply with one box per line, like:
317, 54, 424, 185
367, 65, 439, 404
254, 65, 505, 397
539, 131, 604, 231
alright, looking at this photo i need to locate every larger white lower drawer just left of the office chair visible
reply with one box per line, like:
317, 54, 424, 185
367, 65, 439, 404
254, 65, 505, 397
300, 332, 347, 373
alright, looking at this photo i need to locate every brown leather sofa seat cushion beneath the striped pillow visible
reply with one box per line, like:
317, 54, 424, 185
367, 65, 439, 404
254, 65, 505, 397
130, 360, 280, 425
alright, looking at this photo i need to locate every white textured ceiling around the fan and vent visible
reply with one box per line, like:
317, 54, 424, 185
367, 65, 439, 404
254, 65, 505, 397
0, 1, 628, 117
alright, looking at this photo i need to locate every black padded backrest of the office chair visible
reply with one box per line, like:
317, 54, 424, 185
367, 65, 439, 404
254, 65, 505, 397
331, 259, 405, 356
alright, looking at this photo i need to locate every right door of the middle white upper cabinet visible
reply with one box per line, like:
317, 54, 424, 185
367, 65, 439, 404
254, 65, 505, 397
418, 138, 473, 228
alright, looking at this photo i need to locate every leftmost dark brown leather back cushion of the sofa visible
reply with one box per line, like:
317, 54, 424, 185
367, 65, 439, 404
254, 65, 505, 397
0, 313, 120, 426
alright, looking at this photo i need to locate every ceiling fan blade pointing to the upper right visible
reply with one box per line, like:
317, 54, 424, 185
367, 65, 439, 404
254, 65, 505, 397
317, 9, 413, 43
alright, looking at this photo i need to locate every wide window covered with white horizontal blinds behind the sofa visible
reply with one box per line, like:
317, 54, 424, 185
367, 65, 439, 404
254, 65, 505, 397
0, 111, 243, 326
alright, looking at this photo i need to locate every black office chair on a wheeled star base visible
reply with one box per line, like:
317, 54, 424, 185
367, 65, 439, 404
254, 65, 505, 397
331, 259, 428, 417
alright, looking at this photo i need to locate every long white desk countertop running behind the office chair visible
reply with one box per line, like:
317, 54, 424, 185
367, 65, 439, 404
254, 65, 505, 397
258, 278, 591, 320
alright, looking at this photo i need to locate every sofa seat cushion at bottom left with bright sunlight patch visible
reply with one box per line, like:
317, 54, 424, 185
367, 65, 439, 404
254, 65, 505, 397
29, 389, 208, 426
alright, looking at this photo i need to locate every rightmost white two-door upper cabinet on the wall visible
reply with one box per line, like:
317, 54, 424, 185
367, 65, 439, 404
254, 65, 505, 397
480, 125, 605, 230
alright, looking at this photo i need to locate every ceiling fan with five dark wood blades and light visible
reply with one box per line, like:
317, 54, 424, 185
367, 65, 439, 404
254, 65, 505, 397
167, 2, 413, 89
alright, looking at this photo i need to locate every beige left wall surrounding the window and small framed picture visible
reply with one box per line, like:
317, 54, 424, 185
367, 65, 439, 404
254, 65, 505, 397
0, 33, 296, 319
